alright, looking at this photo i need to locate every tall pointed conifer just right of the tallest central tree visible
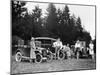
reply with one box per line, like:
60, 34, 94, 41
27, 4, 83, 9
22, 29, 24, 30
59, 5, 72, 44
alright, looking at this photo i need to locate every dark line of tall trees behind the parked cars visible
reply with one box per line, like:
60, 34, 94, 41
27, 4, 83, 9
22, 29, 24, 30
11, 1, 94, 44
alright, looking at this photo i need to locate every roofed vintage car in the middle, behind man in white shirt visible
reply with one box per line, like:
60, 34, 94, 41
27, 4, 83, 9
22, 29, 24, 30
35, 37, 65, 61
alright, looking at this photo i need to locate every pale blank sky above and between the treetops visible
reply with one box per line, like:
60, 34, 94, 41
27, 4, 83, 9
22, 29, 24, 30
25, 2, 95, 39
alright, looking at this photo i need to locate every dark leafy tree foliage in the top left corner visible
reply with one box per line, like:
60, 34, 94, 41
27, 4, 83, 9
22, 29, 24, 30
11, 0, 27, 22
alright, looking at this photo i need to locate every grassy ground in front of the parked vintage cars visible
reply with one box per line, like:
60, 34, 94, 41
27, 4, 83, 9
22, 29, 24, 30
11, 57, 96, 74
